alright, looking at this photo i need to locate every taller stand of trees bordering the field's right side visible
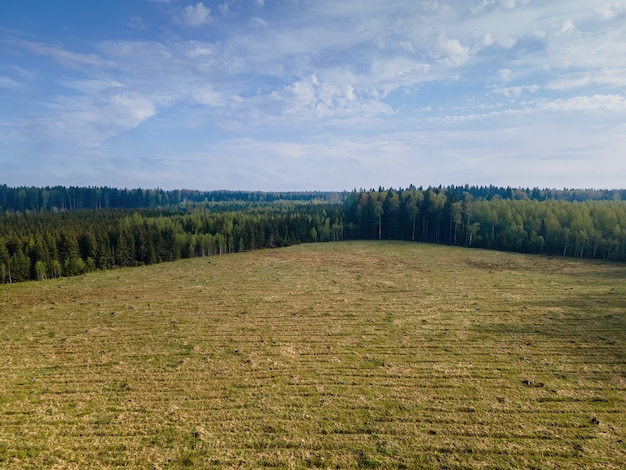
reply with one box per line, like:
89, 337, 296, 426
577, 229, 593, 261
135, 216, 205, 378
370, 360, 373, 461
346, 188, 626, 261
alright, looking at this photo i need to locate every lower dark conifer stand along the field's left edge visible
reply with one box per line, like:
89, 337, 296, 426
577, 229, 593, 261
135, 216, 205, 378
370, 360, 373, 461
0, 203, 343, 283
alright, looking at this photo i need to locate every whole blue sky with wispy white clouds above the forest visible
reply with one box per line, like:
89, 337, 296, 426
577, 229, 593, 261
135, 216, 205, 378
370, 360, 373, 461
0, 0, 626, 191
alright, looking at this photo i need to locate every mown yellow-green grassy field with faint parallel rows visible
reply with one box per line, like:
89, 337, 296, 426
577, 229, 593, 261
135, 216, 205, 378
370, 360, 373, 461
0, 242, 626, 469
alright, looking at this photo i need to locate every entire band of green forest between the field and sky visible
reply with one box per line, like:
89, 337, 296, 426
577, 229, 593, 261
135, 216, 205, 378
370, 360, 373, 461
0, 185, 626, 283
